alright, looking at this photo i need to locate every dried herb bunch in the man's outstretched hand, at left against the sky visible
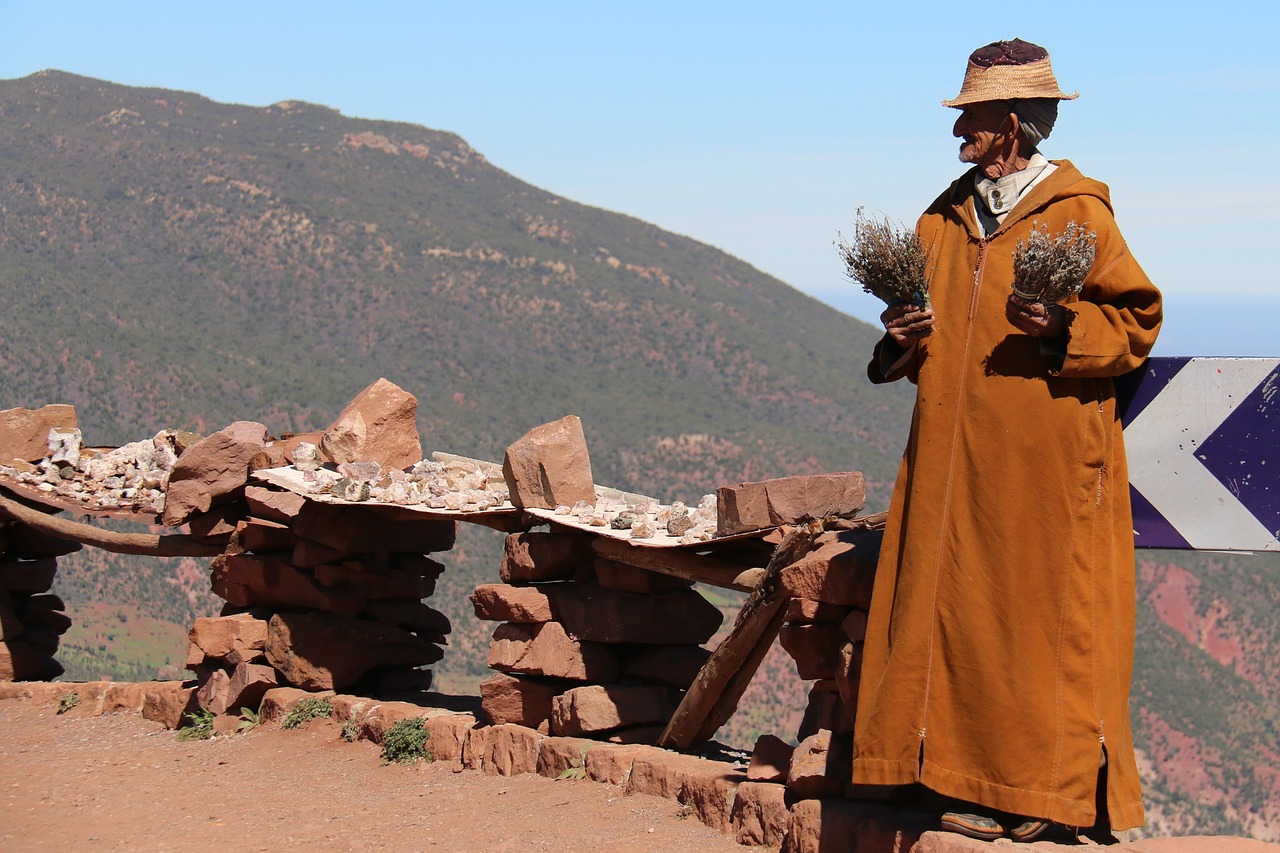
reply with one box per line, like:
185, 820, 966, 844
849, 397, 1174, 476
836, 207, 929, 307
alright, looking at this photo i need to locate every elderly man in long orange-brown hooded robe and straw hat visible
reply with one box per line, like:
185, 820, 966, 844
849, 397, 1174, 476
854, 40, 1161, 841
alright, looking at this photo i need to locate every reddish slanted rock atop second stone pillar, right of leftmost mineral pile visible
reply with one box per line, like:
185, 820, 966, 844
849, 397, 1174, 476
163, 421, 266, 526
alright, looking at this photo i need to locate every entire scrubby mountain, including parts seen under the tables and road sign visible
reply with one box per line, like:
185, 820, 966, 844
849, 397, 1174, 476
0, 72, 1280, 839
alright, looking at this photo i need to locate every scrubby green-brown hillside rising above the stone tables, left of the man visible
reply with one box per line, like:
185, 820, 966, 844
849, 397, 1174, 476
0, 72, 910, 501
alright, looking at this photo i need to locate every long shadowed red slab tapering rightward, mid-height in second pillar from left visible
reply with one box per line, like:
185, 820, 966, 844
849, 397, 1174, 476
210, 555, 366, 616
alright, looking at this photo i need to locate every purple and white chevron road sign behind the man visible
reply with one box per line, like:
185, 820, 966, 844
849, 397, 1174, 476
1116, 359, 1280, 551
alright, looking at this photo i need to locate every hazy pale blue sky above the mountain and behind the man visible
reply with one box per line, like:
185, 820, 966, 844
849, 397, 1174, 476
0, 0, 1280, 355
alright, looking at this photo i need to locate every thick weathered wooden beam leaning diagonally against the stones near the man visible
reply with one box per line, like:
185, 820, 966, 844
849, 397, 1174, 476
658, 521, 823, 749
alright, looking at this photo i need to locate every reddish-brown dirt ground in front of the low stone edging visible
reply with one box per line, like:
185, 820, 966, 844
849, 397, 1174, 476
0, 699, 749, 853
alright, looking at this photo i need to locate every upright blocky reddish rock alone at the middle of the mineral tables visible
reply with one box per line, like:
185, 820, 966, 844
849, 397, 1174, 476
502, 415, 595, 510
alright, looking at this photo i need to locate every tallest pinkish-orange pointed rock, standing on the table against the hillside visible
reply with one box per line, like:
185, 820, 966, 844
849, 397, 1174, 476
320, 379, 422, 469
